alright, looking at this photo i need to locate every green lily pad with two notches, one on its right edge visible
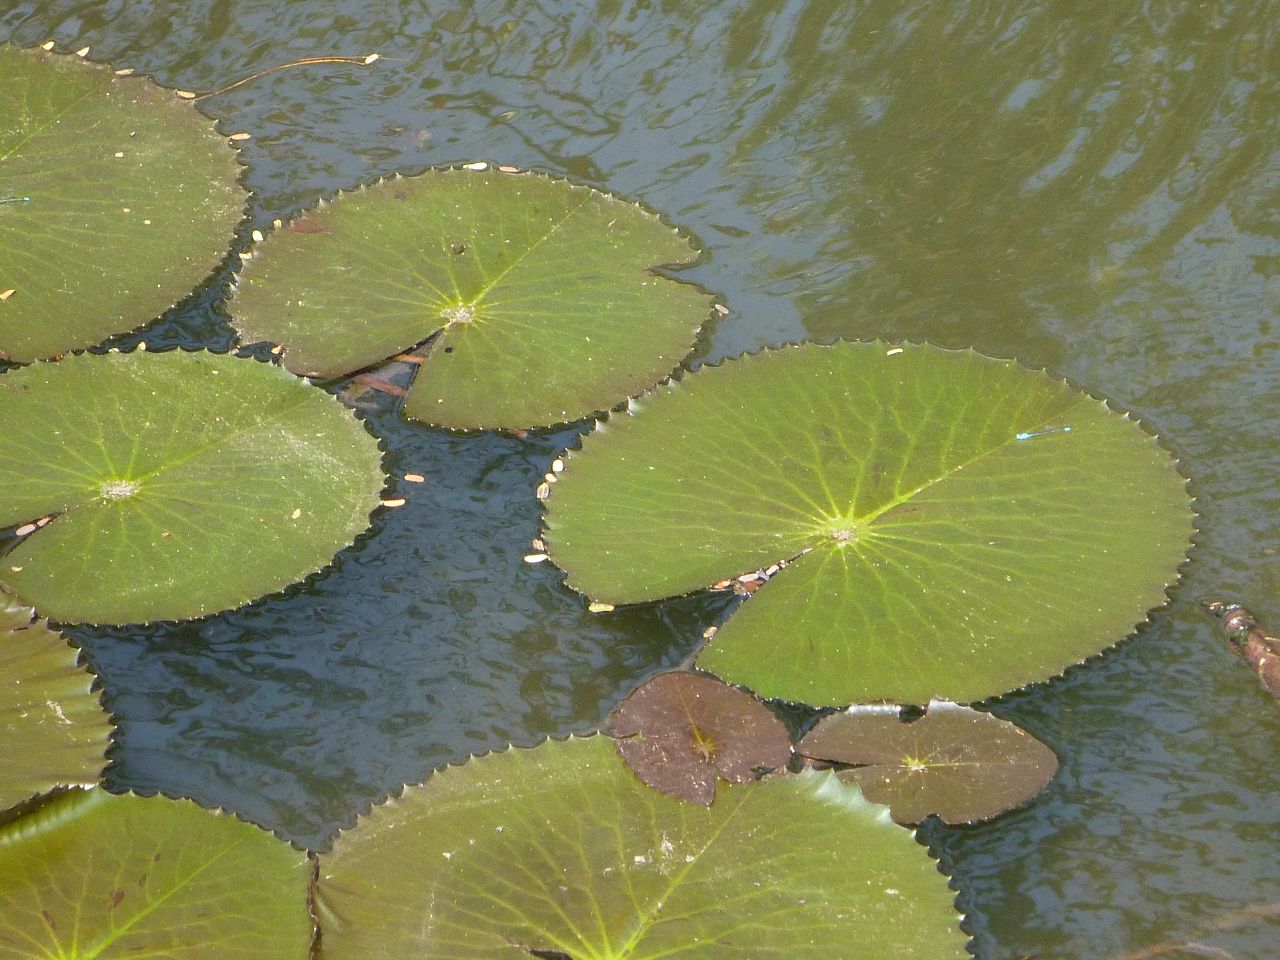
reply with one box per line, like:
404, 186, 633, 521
230, 169, 712, 430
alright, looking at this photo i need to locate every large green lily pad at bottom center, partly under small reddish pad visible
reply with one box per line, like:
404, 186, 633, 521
316, 737, 968, 960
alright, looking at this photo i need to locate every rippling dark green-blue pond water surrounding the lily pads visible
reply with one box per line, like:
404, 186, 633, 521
0, 0, 1280, 960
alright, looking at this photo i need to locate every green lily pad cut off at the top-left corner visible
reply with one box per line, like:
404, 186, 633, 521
0, 45, 247, 362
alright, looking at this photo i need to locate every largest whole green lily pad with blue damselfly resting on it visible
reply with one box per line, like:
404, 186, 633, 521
544, 342, 1193, 704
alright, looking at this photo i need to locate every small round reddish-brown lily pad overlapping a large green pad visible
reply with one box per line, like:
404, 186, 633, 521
612, 671, 791, 806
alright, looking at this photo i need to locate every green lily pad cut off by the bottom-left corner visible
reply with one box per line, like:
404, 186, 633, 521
0, 788, 312, 960
